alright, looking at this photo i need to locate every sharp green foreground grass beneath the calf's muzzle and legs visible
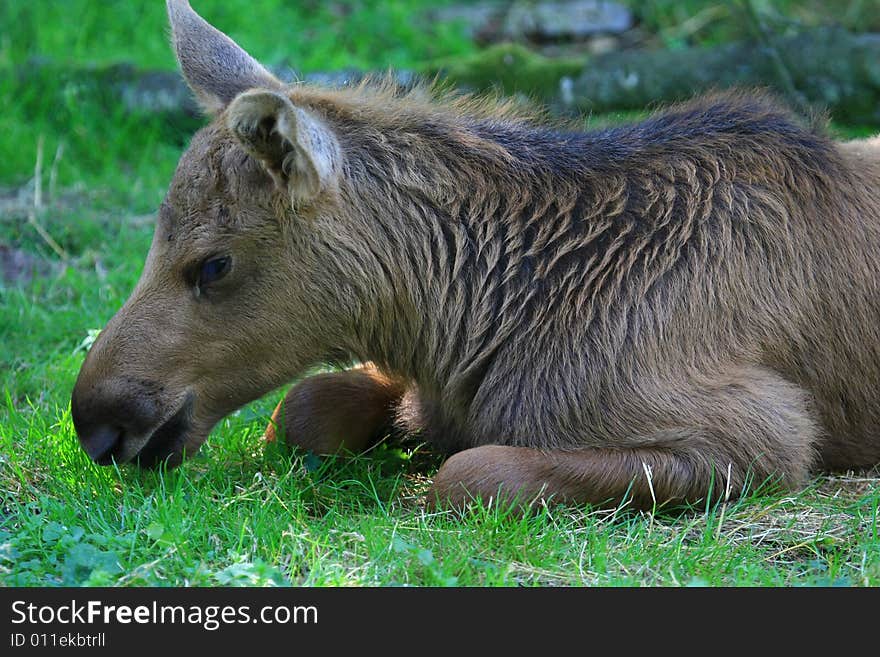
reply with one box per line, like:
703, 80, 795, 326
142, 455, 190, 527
0, 380, 880, 586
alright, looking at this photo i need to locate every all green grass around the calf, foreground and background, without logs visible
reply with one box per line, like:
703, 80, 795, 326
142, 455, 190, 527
0, 0, 880, 586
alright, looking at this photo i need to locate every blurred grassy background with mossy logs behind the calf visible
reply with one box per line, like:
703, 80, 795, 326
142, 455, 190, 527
0, 0, 880, 410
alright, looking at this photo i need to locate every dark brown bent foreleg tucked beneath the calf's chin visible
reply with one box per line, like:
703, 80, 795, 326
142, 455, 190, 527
265, 364, 407, 454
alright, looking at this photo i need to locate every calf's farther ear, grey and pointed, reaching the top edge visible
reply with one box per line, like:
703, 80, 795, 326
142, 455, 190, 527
167, 0, 283, 114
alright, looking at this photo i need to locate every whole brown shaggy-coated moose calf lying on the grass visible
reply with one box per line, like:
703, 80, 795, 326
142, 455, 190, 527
72, 0, 880, 507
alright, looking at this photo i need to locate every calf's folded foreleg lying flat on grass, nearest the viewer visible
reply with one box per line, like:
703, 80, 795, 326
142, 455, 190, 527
429, 368, 818, 509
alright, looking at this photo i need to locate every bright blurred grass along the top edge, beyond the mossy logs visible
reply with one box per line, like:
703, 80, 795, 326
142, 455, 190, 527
0, 0, 482, 72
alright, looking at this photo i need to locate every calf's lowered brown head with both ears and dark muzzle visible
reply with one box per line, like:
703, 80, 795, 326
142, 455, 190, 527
71, 0, 342, 465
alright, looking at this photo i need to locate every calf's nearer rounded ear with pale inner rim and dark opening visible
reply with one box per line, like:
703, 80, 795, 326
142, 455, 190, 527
226, 89, 341, 204
